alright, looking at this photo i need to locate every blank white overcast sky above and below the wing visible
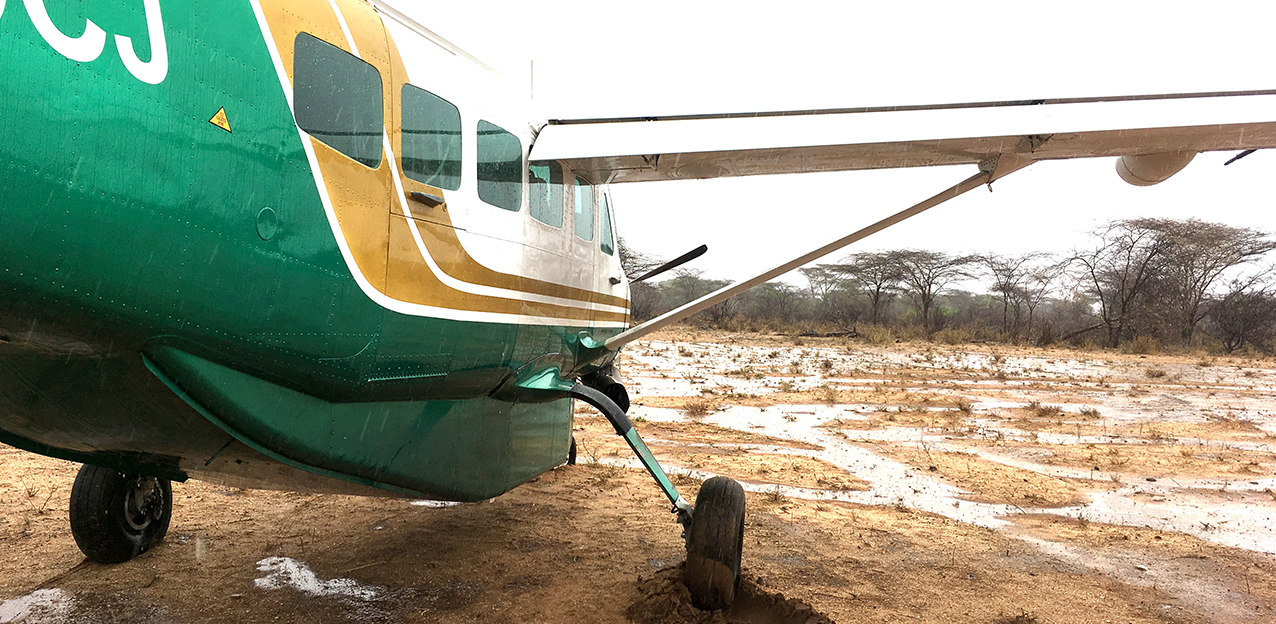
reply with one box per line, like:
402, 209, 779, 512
397, 0, 1276, 279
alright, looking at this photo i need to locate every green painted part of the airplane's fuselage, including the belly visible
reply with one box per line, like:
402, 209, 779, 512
0, 0, 612, 500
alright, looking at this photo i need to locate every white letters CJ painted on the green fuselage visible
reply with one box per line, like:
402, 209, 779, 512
23, 0, 168, 84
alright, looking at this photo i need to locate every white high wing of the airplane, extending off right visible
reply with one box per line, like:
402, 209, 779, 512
531, 91, 1276, 184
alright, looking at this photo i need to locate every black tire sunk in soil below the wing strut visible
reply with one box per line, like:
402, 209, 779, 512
683, 477, 744, 610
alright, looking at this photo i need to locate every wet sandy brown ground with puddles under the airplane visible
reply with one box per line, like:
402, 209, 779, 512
0, 331, 1276, 624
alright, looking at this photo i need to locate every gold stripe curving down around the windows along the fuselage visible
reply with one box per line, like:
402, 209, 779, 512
260, 0, 629, 324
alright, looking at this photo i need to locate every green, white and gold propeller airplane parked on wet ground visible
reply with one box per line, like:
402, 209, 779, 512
0, 0, 1276, 609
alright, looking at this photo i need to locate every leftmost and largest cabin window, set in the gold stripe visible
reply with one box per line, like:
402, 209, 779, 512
292, 33, 385, 167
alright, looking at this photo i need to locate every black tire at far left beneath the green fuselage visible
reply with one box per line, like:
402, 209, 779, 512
70, 463, 172, 564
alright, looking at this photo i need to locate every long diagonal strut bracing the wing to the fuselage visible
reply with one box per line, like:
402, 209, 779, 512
604, 154, 1034, 351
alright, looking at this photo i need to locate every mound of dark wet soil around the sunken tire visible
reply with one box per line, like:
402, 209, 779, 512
625, 564, 833, 624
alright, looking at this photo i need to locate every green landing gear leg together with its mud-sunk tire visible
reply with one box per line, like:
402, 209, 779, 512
572, 384, 744, 609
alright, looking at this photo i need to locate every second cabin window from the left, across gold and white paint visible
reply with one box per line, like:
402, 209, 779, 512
402, 84, 461, 190
